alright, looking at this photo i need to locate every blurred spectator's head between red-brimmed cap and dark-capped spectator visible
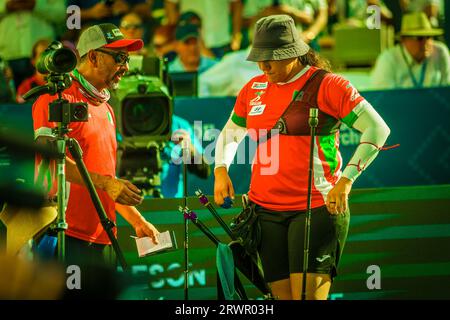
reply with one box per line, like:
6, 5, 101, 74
152, 25, 177, 63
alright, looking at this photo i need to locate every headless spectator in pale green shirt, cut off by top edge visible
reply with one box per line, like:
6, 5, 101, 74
165, 0, 242, 58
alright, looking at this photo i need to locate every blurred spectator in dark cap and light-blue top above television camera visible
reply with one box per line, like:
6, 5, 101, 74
169, 24, 217, 73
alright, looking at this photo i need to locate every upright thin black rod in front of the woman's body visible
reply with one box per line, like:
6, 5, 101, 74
301, 108, 319, 300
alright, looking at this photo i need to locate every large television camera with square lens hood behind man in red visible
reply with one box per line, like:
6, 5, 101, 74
112, 56, 173, 198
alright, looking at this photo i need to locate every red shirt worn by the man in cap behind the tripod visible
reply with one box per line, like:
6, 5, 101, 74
33, 81, 117, 244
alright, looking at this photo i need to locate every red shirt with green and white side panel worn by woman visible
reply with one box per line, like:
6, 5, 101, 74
232, 67, 365, 211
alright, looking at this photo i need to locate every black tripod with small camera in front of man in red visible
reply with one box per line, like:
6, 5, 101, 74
24, 74, 128, 271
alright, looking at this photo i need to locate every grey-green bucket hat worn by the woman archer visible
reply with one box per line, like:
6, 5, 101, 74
247, 14, 309, 62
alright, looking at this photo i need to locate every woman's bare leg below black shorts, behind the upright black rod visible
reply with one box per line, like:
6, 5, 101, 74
290, 273, 331, 300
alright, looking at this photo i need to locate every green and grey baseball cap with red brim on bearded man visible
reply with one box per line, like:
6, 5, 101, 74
77, 23, 144, 57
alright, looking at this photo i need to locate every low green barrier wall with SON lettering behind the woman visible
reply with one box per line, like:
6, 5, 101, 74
119, 185, 450, 299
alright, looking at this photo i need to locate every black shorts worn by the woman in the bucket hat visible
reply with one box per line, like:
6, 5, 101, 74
256, 205, 350, 282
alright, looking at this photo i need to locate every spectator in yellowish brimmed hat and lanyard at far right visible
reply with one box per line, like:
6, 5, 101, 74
371, 12, 450, 89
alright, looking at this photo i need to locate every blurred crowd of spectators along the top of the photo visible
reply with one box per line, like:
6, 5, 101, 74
0, 0, 449, 102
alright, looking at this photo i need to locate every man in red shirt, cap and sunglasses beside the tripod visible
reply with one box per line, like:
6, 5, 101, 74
33, 23, 158, 264
